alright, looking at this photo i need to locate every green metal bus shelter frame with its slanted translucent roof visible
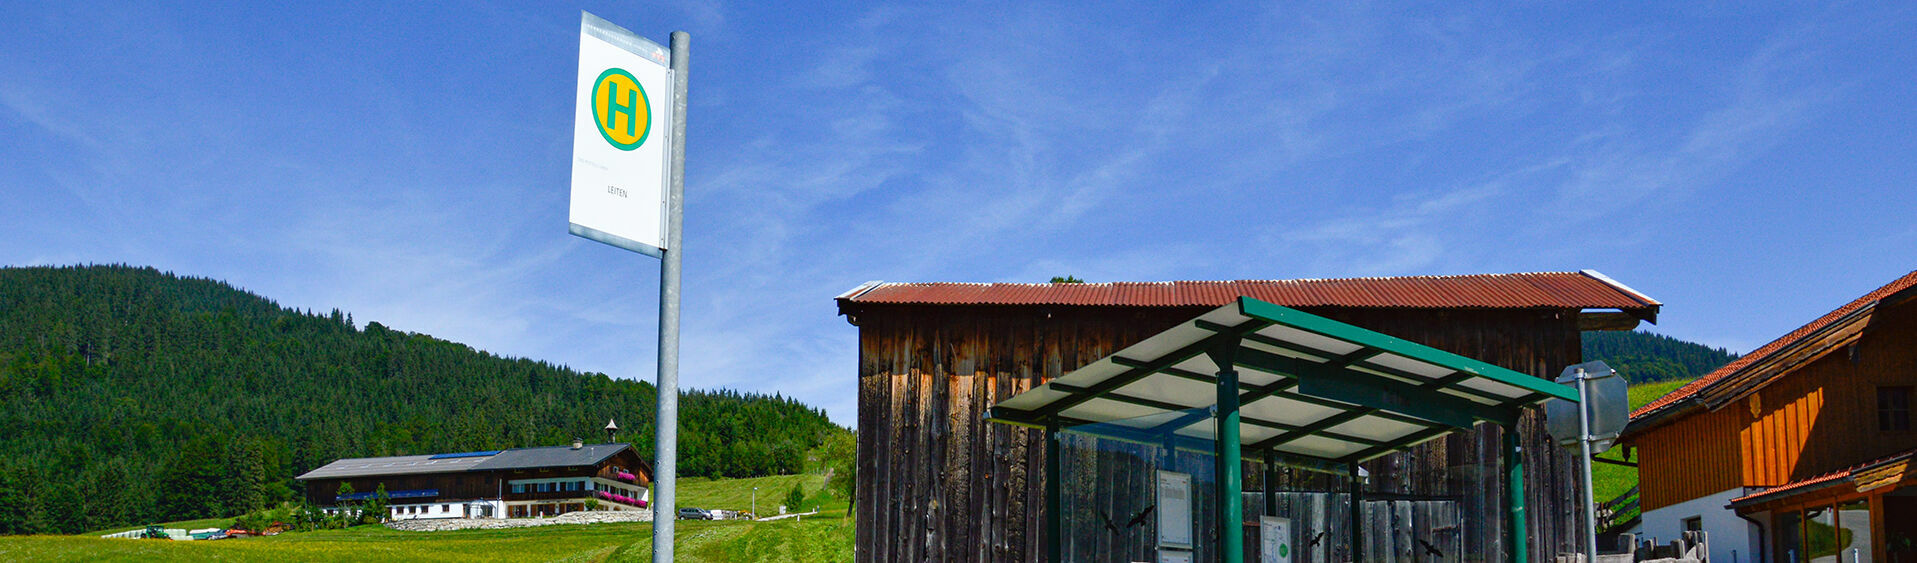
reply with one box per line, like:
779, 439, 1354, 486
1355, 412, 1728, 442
987, 297, 1578, 563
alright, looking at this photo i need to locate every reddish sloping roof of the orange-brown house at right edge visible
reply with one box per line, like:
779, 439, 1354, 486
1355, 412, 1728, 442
1631, 272, 1917, 427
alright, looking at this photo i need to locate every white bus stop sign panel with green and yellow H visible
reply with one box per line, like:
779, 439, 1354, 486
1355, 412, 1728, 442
567, 13, 673, 257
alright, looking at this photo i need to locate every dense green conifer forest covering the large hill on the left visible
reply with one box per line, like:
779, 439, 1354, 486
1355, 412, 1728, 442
0, 266, 849, 534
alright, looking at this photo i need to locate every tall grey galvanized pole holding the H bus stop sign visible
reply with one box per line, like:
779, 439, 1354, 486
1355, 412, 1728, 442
652, 31, 692, 563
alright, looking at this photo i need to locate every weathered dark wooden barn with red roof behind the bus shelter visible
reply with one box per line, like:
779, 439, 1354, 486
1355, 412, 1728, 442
838, 270, 1660, 561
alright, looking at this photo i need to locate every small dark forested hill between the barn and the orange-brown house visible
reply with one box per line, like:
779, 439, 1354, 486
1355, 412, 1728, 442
1583, 331, 1737, 383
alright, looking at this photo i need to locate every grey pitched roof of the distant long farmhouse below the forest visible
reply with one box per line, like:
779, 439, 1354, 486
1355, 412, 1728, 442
295, 444, 633, 481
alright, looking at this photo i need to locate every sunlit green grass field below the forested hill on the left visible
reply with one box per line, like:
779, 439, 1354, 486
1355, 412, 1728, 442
0, 475, 853, 561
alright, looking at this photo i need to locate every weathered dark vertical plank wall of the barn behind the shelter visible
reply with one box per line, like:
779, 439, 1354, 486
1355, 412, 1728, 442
849, 304, 1582, 561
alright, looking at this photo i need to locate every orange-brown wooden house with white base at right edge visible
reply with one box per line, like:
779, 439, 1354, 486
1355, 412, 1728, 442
1622, 272, 1917, 561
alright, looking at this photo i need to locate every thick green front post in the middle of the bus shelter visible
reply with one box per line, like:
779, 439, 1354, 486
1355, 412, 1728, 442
1208, 337, 1244, 563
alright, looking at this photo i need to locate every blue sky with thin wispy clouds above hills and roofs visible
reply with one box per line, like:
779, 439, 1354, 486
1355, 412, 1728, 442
0, 2, 1917, 425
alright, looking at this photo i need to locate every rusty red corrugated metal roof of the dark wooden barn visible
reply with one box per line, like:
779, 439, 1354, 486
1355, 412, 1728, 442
838, 270, 1660, 314
